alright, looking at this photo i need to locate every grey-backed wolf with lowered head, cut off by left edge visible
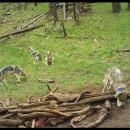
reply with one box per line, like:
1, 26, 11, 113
0, 65, 26, 85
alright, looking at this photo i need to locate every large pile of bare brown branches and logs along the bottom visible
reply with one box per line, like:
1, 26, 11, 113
0, 80, 123, 128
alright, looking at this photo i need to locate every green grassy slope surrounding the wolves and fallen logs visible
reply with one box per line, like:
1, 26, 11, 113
0, 3, 130, 101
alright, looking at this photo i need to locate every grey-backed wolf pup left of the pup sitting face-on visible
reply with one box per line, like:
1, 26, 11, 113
28, 46, 42, 64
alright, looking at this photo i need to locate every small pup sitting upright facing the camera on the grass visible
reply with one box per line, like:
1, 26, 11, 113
45, 51, 54, 66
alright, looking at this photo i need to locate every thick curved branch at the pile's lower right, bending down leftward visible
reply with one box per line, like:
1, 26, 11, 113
77, 100, 111, 128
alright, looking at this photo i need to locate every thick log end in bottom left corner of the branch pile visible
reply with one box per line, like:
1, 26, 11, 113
0, 118, 22, 126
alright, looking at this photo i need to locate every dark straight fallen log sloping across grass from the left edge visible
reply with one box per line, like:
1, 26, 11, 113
0, 24, 45, 39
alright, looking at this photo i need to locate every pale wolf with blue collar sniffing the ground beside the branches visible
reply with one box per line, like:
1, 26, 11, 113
102, 67, 128, 107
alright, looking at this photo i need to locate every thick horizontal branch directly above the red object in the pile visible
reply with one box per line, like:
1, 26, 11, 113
18, 112, 58, 119
